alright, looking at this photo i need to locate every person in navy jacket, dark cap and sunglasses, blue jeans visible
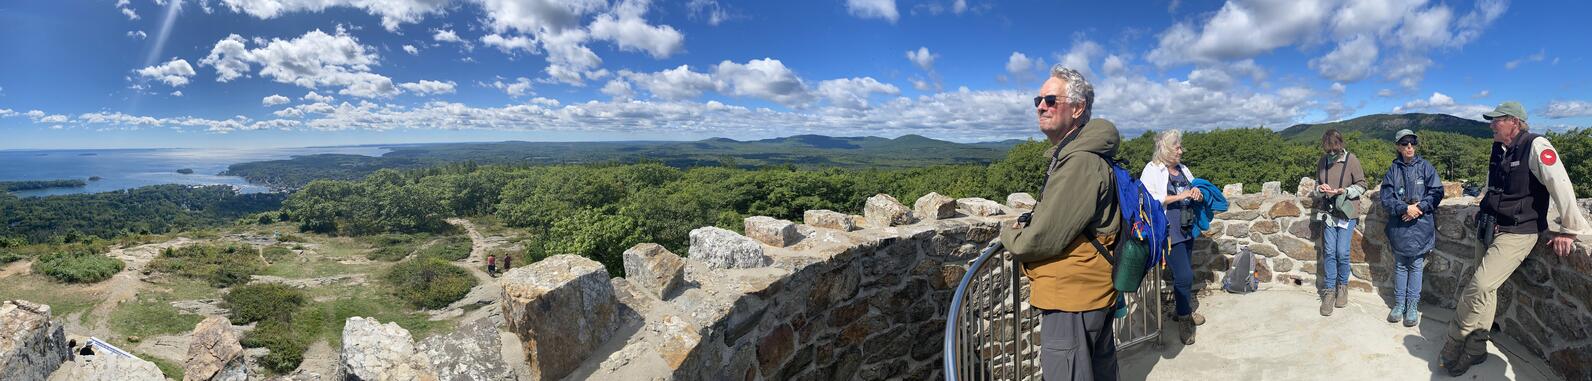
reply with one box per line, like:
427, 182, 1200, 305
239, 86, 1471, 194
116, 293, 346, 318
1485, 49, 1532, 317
1377, 129, 1442, 327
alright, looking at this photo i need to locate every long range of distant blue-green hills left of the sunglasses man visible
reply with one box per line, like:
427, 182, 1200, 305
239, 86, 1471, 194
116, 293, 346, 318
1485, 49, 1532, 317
223, 136, 1024, 188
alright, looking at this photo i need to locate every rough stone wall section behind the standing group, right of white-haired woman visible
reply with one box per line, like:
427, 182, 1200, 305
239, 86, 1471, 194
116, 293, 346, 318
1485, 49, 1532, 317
1194, 179, 1592, 379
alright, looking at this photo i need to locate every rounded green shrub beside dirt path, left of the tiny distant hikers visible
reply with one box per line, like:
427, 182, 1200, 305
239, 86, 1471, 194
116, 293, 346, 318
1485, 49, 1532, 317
384, 257, 476, 309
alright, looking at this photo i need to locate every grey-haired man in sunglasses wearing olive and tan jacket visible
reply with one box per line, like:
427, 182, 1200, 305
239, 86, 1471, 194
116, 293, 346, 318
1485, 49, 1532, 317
1000, 65, 1122, 381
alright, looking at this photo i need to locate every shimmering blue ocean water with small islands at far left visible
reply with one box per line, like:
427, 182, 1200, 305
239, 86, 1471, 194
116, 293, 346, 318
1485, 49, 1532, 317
0, 147, 388, 198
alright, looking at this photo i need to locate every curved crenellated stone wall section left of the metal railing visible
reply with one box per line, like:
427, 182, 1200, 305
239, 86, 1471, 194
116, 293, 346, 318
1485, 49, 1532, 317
505, 194, 1016, 379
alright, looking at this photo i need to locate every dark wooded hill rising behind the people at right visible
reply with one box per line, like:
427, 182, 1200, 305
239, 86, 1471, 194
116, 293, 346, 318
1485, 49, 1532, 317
1280, 113, 1492, 143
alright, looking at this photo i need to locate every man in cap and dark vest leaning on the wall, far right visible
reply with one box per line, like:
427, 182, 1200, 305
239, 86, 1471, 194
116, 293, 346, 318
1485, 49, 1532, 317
1439, 102, 1592, 376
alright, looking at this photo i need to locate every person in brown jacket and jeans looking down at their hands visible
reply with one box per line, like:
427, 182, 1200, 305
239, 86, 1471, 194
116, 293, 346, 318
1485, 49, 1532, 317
1313, 129, 1366, 316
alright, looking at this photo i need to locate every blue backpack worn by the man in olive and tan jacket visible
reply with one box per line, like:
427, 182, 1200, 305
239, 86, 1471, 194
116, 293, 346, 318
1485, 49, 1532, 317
1089, 155, 1169, 292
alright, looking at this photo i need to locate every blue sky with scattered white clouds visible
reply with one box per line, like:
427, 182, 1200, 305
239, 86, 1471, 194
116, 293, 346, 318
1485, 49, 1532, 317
0, 0, 1592, 148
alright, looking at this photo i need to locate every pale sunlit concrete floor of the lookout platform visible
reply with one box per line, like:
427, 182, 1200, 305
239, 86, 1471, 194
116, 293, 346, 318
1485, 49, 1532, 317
1118, 285, 1559, 381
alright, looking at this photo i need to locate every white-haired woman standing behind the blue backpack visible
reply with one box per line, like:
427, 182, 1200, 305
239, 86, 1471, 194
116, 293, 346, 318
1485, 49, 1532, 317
1138, 129, 1205, 344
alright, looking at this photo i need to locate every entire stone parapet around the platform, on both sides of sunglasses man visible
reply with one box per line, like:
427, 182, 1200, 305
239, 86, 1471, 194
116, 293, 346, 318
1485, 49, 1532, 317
487, 182, 1592, 379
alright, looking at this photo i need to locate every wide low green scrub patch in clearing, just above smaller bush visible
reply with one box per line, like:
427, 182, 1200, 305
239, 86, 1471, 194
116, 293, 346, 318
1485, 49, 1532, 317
150, 245, 266, 289
